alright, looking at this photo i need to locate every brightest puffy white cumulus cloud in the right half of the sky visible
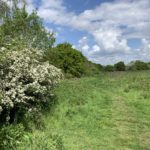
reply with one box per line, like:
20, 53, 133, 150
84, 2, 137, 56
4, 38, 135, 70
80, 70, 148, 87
92, 27, 130, 53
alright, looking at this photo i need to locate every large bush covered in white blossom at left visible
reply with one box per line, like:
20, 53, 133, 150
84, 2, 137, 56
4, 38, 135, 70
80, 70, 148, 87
0, 49, 63, 123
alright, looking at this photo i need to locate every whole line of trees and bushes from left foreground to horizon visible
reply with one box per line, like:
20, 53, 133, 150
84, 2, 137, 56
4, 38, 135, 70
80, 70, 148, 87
0, 0, 150, 150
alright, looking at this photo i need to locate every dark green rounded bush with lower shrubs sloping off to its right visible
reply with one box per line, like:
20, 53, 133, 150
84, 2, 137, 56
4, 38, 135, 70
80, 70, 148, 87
44, 43, 99, 77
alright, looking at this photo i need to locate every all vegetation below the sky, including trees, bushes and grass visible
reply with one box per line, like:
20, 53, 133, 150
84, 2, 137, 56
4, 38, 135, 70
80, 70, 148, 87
0, 0, 150, 150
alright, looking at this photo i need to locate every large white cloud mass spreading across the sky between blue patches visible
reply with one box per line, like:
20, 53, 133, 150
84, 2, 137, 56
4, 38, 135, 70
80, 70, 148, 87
28, 0, 150, 63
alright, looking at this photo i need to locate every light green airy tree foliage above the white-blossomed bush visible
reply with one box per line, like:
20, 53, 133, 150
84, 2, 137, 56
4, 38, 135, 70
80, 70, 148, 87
0, 7, 55, 50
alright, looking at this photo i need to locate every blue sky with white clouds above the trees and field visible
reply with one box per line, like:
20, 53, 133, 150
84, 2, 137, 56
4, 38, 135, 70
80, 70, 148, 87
27, 0, 150, 64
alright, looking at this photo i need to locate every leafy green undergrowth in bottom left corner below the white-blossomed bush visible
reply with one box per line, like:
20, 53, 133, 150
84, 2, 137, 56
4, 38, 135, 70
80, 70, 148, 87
0, 124, 25, 150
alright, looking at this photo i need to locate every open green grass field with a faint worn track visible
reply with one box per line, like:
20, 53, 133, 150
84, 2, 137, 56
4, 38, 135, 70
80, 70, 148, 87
19, 71, 150, 150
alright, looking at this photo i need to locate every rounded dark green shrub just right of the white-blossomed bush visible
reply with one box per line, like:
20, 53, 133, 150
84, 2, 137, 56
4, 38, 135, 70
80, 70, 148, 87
45, 43, 86, 77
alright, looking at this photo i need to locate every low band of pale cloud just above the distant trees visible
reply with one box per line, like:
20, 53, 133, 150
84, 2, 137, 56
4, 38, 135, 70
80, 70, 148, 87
77, 37, 150, 65
